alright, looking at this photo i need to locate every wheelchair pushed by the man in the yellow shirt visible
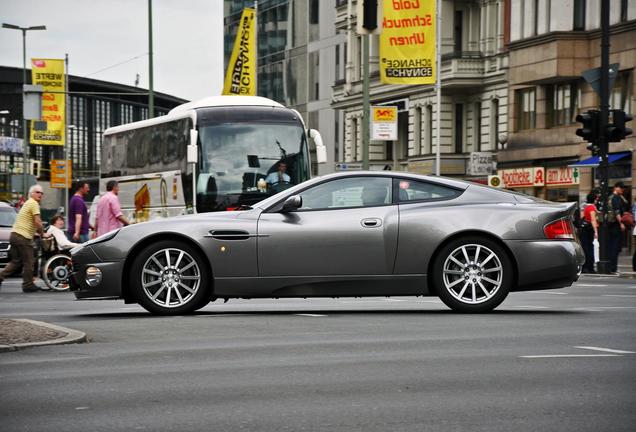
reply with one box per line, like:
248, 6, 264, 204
34, 237, 73, 291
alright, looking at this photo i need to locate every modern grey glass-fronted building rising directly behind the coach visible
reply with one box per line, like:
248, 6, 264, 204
224, 0, 344, 174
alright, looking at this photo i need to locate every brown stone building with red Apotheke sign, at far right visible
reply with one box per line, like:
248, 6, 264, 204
497, 0, 636, 201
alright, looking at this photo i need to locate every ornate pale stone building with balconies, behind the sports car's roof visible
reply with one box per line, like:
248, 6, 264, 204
333, 0, 508, 181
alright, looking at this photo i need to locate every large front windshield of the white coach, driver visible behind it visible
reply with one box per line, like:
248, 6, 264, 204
197, 121, 309, 212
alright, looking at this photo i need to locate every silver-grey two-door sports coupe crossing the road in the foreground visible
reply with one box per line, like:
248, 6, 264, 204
71, 171, 584, 314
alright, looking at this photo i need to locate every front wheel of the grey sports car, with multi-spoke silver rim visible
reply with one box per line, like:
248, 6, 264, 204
129, 240, 209, 315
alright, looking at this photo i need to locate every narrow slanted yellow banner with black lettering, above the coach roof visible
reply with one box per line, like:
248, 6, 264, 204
223, 8, 256, 96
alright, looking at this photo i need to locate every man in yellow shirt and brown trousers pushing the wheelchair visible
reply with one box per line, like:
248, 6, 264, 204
0, 184, 51, 292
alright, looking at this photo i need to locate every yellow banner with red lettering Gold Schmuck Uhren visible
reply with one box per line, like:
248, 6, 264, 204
380, 0, 437, 84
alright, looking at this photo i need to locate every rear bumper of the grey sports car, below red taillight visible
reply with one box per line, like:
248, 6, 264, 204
506, 240, 585, 291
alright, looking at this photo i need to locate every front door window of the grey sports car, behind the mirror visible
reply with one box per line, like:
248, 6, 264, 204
299, 177, 392, 210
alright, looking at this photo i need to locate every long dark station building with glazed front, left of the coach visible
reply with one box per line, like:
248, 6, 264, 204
0, 66, 187, 208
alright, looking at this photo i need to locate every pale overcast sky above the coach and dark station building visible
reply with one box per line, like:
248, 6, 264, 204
0, 0, 224, 100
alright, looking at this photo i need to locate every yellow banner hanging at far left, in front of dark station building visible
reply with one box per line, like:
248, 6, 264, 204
31, 59, 66, 146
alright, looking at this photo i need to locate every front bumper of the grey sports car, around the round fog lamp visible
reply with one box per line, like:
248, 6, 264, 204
69, 246, 124, 299
